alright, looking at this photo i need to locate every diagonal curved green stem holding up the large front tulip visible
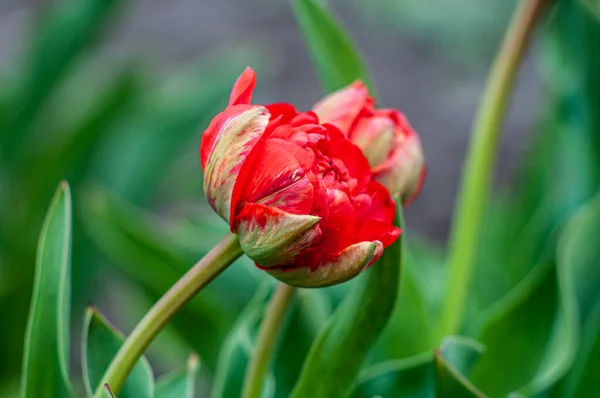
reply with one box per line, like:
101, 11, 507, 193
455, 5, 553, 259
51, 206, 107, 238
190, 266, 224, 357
95, 234, 243, 398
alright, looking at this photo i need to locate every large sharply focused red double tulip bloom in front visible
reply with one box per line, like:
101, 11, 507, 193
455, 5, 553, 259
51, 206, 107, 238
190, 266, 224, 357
200, 68, 401, 287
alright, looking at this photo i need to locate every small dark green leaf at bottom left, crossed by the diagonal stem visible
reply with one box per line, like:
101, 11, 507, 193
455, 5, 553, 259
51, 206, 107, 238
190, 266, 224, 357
81, 308, 154, 398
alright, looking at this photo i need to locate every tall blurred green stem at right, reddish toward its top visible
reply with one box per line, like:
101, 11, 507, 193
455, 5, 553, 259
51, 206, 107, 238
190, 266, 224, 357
442, 0, 549, 334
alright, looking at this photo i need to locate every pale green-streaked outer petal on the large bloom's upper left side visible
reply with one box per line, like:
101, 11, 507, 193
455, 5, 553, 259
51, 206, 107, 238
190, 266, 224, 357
201, 105, 269, 223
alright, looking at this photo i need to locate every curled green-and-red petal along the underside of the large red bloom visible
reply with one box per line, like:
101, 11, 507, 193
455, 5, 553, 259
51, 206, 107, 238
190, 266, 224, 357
265, 241, 383, 288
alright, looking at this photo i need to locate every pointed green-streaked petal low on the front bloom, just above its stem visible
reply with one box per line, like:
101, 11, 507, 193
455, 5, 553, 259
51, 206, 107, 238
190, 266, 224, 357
234, 203, 321, 267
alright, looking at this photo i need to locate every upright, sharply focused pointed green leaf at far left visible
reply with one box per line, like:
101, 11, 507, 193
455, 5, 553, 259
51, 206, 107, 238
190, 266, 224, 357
23, 182, 72, 398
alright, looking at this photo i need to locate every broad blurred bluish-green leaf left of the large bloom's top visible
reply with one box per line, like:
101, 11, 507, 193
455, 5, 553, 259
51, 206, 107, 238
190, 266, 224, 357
98, 44, 268, 205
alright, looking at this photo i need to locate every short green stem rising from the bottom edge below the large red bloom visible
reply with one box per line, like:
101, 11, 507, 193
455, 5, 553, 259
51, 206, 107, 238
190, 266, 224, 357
242, 283, 296, 398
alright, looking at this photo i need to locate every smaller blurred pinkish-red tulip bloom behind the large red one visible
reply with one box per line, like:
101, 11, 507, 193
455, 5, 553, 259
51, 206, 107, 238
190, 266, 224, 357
313, 81, 426, 205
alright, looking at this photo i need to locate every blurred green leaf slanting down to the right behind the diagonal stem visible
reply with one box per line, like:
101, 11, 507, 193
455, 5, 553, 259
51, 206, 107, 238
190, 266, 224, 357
81, 186, 263, 371
